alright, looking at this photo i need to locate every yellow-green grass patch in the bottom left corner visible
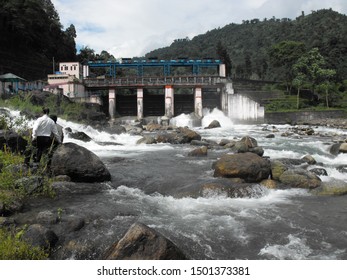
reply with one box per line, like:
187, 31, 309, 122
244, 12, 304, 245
0, 228, 48, 260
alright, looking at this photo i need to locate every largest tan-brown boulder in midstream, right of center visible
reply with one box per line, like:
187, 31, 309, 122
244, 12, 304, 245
214, 152, 271, 182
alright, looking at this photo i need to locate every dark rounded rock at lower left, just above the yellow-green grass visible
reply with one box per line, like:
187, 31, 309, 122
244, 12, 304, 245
23, 224, 58, 249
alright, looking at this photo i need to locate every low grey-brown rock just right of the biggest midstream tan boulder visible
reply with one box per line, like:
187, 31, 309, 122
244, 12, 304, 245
279, 169, 321, 189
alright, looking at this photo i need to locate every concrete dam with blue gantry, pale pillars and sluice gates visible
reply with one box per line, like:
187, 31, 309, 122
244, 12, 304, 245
84, 60, 264, 123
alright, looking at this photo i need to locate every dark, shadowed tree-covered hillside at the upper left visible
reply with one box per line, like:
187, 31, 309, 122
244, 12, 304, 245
0, 0, 76, 80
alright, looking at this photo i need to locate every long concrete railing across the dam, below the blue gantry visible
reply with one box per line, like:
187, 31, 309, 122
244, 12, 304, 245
84, 76, 225, 87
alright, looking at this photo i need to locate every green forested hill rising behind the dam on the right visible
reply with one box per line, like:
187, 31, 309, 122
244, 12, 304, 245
146, 9, 347, 80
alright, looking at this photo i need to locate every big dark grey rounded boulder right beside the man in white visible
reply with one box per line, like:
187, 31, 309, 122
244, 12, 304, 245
51, 143, 111, 182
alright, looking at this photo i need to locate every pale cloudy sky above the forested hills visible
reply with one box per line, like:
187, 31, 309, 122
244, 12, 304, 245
51, 0, 347, 58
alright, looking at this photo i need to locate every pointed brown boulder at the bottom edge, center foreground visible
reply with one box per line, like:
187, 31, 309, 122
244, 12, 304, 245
104, 223, 187, 260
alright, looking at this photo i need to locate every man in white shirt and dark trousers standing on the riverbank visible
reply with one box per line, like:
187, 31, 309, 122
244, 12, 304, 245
32, 108, 61, 162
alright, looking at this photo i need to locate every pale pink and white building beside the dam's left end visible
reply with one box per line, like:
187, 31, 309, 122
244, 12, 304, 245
45, 62, 87, 99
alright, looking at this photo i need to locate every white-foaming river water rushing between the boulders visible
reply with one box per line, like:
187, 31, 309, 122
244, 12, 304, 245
4, 110, 347, 259
